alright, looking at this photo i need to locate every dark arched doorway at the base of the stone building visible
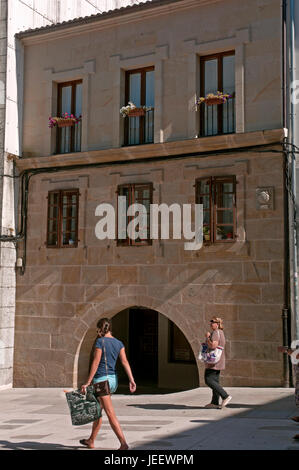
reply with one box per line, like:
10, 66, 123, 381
78, 306, 199, 394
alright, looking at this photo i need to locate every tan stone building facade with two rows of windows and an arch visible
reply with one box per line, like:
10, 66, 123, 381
14, 0, 285, 389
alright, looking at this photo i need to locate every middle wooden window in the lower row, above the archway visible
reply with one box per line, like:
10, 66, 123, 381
117, 183, 153, 246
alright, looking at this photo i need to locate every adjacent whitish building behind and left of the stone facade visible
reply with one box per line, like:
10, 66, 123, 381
0, 0, 150, 389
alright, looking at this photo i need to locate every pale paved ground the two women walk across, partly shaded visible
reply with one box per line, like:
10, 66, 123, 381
0, 387, 299, 452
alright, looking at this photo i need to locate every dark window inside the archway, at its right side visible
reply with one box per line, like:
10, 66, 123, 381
168, 321, 195, 364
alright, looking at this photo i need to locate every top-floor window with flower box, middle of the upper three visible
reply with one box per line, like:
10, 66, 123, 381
124, 67, 155, 145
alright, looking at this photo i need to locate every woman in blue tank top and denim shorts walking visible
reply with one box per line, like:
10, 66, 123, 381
80, 318, 136, 450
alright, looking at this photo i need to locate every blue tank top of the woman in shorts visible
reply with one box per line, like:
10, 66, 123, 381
94, 337, 124, 378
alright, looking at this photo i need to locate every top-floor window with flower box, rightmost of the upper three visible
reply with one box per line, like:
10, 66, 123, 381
200, 52, 236, 137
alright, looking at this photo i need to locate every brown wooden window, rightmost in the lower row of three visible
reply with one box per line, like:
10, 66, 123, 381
196, 176, 236, 243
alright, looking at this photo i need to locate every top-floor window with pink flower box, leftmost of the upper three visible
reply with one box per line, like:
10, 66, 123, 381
56, 80, 82, 153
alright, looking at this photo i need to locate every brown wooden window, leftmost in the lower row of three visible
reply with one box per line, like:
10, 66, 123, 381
47, 189, 79, 248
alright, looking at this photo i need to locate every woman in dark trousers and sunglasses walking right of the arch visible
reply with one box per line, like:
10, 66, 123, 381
205, 317, 232, 409
